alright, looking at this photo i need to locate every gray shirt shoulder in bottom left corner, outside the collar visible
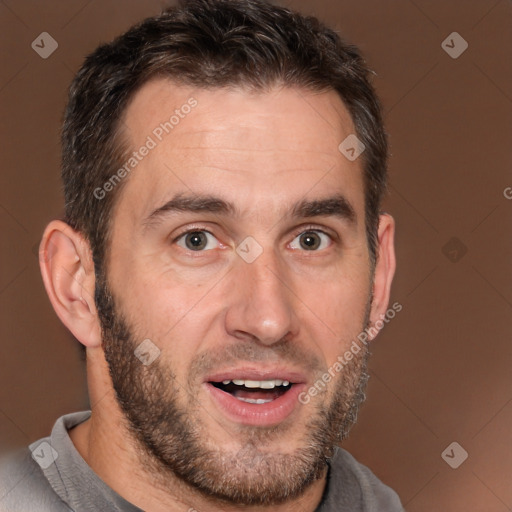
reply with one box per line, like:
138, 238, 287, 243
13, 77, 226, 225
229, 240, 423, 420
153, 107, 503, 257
0, 448, 71, 512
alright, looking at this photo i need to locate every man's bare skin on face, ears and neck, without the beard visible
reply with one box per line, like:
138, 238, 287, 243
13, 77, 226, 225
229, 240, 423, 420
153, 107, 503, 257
40, 79, 395, 512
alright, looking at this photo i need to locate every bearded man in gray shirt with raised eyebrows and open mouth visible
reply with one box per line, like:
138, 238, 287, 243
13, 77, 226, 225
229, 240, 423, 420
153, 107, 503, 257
0, 0, 402, 512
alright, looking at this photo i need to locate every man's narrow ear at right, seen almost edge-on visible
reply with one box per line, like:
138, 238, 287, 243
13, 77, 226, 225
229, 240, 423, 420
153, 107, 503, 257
369, 213, 396, 338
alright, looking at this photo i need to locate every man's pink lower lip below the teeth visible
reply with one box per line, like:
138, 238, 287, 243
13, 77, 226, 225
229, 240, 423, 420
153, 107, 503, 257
205, 382, 305, 426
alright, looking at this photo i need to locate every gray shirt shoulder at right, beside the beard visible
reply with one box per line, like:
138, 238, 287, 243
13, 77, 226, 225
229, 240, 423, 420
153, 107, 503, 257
326, 448, 404, 512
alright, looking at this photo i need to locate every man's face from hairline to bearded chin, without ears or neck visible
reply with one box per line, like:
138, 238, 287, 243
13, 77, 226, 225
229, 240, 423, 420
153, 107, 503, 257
97, 80, 372, 505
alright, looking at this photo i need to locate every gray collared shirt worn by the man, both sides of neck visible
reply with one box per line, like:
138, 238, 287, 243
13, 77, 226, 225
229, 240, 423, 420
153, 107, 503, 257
0, 411, 404, 512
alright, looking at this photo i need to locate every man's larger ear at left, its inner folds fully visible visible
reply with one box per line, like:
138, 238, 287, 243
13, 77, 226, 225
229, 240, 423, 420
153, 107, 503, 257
39, 220, 101, 348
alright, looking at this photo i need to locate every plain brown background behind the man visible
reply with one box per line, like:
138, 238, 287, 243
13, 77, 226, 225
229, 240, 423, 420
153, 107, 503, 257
0, 0, 512, 512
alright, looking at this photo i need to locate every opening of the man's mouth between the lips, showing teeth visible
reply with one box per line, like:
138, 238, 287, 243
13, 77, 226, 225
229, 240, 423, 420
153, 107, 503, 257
210, 379, 294, 405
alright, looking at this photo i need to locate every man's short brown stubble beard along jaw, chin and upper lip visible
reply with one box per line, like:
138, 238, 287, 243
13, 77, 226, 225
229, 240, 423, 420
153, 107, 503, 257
96, 279, 369, 506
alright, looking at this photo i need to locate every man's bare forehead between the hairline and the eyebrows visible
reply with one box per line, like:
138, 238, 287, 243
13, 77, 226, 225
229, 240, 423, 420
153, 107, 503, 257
119, 79, 363, 221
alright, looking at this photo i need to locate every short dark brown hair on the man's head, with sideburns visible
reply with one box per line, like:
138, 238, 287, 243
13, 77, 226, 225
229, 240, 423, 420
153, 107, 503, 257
62, 0, 387, 275
